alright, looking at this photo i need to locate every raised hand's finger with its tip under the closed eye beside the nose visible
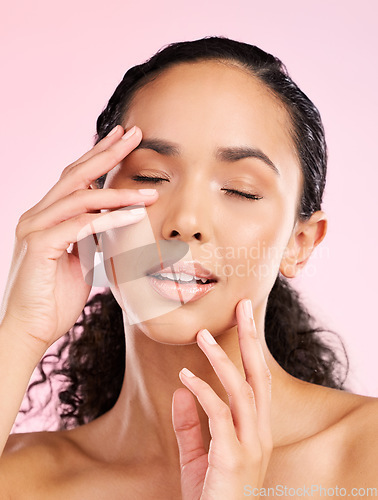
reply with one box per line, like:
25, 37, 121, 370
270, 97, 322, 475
17, 188, 158, 239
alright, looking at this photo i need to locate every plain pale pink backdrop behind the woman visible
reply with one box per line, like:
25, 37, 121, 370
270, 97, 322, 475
0, 0, 378, 430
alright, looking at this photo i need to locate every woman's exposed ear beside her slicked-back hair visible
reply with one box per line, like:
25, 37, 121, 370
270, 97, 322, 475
280, 210, 328, 278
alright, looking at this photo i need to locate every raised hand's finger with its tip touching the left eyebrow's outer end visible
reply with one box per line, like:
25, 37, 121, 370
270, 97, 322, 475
21, 127, 142, 220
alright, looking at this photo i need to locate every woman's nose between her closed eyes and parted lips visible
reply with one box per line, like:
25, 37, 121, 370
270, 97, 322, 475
162, 176, 212, 243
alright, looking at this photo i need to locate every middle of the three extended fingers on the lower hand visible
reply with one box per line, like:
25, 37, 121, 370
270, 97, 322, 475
197, 330, 258, 446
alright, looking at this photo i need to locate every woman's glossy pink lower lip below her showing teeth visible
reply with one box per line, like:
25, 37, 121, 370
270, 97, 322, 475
147, 276, 217, 303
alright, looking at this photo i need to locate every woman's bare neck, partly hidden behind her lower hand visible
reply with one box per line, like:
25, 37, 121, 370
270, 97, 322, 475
94, 300, 322, 468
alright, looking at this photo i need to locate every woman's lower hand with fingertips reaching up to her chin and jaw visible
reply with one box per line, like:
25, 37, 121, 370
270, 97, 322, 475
172, 299, 272, 500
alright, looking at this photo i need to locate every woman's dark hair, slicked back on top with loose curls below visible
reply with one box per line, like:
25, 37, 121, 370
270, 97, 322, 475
21, 36, 349, 429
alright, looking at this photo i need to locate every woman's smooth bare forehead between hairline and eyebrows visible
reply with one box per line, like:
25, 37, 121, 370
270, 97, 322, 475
122, 61, 298, 180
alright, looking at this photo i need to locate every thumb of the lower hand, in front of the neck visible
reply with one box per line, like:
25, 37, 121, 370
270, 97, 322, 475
172, 388, 207, 470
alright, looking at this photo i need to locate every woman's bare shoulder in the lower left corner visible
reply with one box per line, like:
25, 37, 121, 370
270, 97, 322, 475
0, 431, 155, 500
